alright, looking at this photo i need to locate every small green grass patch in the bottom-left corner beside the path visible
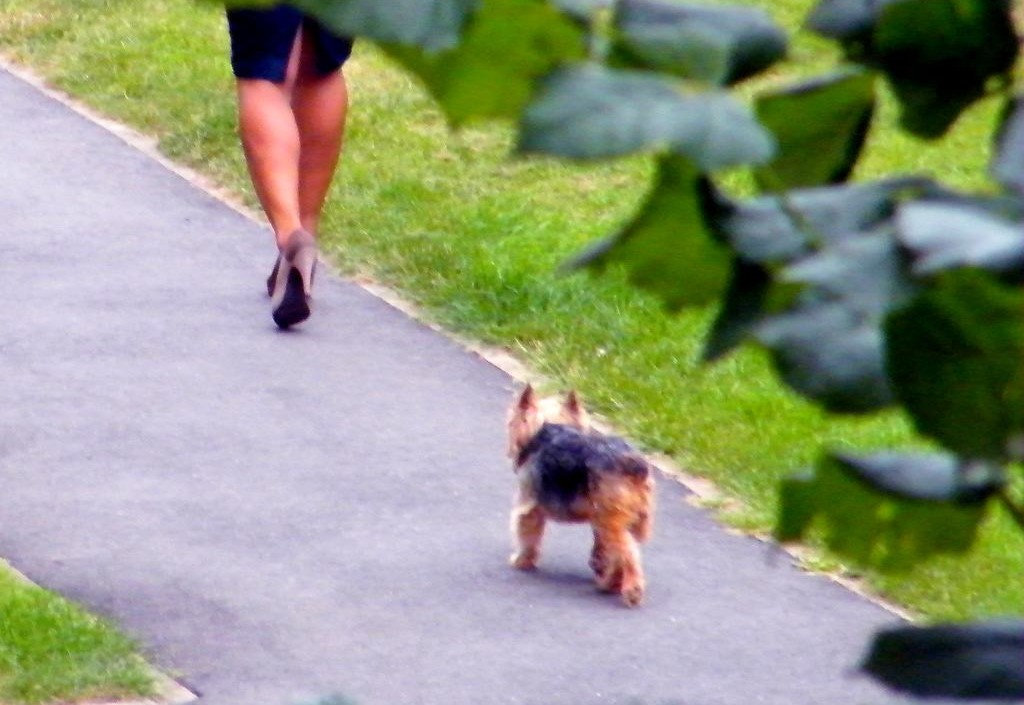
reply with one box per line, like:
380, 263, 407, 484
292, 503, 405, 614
0, 564, 154, 703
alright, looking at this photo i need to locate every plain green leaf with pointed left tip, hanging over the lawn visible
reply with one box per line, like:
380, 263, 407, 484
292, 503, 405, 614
569, 156, 729, 310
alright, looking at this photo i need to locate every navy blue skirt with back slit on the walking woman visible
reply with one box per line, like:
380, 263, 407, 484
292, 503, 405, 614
227, 4, 352, 83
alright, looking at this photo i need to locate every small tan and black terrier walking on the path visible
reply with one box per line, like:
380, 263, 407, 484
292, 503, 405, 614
508, 386, 654, 607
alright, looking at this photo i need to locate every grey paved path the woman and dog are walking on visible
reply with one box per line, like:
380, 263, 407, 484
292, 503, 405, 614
0, 67, 905, 705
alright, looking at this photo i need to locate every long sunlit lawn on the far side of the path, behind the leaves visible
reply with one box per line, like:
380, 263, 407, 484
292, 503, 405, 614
0, 0, 1024, 639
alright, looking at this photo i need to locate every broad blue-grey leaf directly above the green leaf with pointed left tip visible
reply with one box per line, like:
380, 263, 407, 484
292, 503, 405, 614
519, 64, 774, 171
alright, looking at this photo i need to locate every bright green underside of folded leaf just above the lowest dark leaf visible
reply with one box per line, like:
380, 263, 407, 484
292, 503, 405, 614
775, 450, 986, 573
